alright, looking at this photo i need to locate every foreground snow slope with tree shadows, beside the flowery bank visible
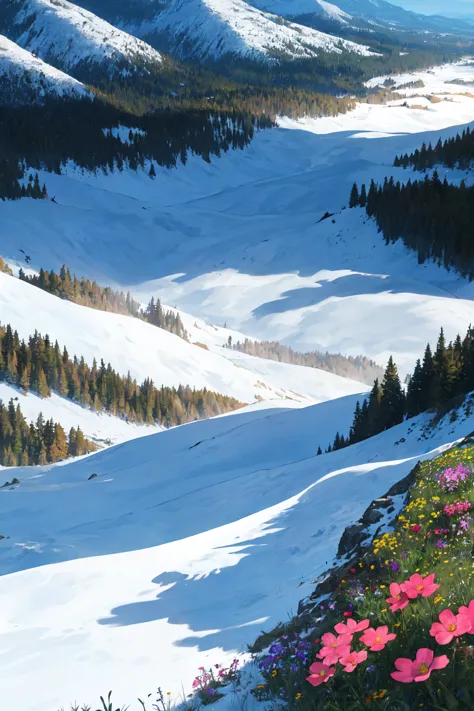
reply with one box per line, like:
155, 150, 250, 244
0, 378, 474, 711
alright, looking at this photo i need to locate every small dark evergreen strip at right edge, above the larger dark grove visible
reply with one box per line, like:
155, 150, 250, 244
393, 126, 474, 170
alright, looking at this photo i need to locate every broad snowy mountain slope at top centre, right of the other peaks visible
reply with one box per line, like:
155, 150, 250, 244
107, 0, 370, 60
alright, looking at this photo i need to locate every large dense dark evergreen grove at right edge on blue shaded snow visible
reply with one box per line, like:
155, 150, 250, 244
349, 171, 474, 279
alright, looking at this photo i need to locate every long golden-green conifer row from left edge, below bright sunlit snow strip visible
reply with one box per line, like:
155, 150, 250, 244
0, 325, 242, 427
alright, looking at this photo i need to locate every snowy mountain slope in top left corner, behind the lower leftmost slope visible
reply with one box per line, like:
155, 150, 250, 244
0, 0, 163, 78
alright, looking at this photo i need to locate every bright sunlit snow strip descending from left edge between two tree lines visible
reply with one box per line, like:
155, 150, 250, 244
0, 273, 367, 404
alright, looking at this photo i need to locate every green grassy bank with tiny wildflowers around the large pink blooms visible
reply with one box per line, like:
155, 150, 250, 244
253, 446, 474, 711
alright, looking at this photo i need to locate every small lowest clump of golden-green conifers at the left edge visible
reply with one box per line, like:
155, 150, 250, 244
0, 399, 97, 467
